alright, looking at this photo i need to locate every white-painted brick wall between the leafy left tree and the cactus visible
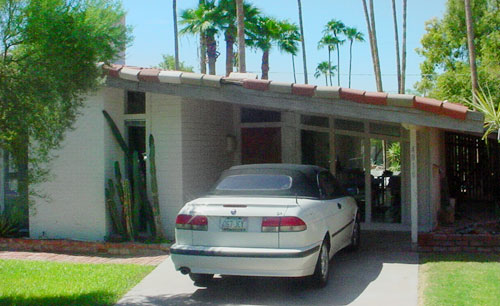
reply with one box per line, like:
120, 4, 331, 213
30, 91, 106, 240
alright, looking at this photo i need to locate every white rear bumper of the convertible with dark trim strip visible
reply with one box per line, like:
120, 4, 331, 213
170, 244, 320, 277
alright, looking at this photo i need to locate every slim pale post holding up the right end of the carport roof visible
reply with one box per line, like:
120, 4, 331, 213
409, 125, 418, 245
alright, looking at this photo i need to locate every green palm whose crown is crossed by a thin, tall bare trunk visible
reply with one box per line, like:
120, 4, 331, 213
218, 0, 260, 76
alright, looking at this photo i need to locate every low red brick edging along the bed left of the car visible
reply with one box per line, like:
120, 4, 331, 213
0, 238, 170, 255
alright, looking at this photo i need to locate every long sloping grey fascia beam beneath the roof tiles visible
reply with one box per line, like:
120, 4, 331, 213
106, 77, 483, 133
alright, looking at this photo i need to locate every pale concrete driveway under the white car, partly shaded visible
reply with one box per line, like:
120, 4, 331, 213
118, 232, 418, 305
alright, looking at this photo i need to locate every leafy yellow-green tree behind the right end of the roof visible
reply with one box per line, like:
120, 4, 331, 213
416, 0, 500, 103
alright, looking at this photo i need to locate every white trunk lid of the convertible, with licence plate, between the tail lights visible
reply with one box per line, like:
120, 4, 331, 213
190, 197, 297, 248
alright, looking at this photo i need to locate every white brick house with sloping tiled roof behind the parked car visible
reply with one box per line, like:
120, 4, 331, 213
0, 65, 483, 242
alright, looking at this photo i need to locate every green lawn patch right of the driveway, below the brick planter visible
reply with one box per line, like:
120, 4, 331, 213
419, 254, 500, 306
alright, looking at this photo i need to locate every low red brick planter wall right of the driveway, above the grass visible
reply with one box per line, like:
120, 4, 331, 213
418, 233, 500, 253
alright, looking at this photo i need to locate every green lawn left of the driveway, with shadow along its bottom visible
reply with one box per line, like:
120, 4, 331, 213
0, 260, 154, 306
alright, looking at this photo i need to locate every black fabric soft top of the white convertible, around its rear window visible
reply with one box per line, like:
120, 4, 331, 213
209, 164, 327, 198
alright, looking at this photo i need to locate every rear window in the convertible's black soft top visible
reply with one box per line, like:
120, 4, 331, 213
215, 174, 292, 190
